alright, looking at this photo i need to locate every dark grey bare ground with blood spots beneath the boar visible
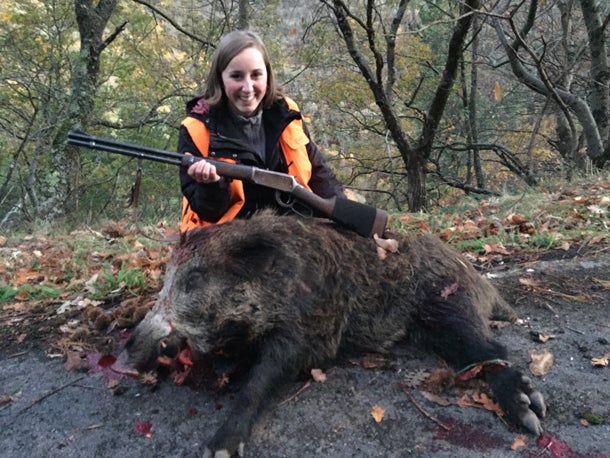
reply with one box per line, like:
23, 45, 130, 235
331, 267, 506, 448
0, 245, 610, 458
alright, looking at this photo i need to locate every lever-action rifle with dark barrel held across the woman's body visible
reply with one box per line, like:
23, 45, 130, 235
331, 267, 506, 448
68, 131, 388, 237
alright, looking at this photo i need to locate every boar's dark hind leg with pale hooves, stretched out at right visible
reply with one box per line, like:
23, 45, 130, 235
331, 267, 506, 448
418, 293, 546, 435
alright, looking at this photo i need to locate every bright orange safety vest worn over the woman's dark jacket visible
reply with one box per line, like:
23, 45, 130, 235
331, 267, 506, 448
180, 97, 311, 232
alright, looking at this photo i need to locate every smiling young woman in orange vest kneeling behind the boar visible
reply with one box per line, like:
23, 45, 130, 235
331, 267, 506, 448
178, 30, 344, 232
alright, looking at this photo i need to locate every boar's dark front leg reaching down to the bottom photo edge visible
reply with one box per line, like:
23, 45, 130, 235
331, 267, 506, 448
203, 335, 304, 458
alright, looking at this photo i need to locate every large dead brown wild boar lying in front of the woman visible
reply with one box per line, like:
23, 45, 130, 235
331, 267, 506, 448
111, 212, 546, 457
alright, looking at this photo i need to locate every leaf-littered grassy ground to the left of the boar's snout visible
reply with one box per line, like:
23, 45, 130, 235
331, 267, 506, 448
0, 226, 171, 358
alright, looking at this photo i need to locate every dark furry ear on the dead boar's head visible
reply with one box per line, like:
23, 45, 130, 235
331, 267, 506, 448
226, 234, 278, 278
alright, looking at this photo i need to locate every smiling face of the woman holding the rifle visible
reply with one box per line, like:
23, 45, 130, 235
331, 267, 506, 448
221, 47, 267, 117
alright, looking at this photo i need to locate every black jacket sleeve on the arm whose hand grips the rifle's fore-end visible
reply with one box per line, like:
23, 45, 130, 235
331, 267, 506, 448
178, 126, 230, 223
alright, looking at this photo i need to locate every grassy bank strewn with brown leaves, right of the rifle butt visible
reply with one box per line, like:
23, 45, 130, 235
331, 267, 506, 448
392, 175, 610, 252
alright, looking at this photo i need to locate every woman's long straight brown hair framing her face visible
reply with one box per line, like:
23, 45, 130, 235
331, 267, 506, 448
203, 30, 284, 108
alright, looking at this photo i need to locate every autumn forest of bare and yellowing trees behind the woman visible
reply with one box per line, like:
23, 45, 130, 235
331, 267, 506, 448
0, 0, 610, 231
